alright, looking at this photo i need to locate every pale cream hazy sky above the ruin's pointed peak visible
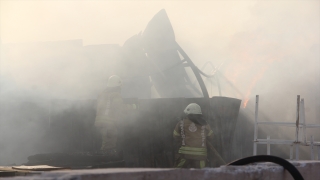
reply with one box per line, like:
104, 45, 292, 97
0, 0, 320, 102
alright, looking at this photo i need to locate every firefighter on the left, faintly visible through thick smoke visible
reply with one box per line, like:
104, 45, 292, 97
94, 75, 124, 154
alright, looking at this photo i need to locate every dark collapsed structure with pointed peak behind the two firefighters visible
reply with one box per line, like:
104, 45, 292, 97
3, 10, 241, 168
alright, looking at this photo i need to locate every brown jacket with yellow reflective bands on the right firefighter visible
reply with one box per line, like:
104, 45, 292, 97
173, 118, 213, 160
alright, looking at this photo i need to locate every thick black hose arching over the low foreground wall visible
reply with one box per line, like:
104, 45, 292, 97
227, 155, 303, 180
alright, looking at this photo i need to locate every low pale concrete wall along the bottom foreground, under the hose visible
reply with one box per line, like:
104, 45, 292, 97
5, 161, 320, 180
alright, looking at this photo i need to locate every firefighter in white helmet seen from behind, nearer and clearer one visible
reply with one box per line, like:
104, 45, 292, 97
173, 103, 213, 168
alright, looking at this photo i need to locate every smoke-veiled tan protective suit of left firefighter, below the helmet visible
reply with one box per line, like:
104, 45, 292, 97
94, 91, 123, 150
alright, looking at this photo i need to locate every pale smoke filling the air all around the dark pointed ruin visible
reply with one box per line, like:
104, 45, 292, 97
0, 1, 320, 165
